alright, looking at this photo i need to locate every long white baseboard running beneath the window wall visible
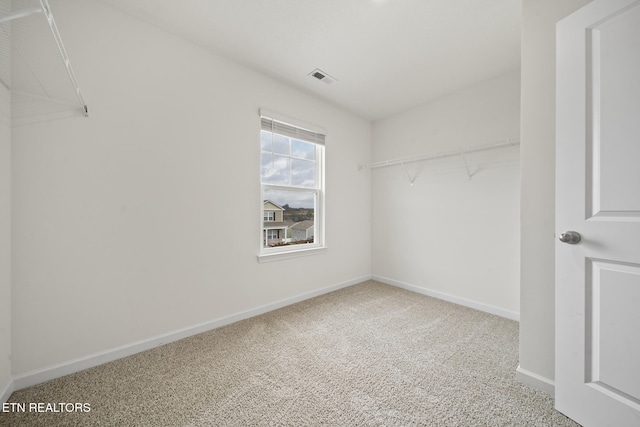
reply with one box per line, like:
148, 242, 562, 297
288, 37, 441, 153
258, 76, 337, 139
12, 275, 371, 392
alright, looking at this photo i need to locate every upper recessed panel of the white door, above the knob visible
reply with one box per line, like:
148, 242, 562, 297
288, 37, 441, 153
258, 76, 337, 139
587, 6, 640, 216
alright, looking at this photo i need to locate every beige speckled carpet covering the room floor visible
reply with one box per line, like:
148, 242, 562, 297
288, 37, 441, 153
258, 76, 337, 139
0, 281, 577, 426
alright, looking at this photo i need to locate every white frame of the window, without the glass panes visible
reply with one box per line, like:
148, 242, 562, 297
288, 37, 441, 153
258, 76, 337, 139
258, 109, 327, 263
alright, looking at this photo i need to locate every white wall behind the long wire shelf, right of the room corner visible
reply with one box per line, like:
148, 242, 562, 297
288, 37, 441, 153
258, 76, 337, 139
372, 70, 520, 318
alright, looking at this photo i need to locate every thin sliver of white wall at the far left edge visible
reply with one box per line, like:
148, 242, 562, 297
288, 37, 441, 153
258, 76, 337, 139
0, 0, 11, 402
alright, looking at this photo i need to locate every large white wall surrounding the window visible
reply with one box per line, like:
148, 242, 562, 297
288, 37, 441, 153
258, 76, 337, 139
8, 0, 371, 382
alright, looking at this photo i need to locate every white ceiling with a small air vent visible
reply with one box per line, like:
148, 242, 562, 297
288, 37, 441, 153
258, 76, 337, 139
102, 0, 521, 120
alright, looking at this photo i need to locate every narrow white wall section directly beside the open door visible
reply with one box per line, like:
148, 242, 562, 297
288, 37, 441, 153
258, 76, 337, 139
518, 0, 589, 393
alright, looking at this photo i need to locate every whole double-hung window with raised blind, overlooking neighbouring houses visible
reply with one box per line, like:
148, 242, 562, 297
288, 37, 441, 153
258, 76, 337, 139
259, 110, 325, 259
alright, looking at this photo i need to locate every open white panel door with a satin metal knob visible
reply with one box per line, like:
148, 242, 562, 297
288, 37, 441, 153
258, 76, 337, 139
555, 0, 640, 427
